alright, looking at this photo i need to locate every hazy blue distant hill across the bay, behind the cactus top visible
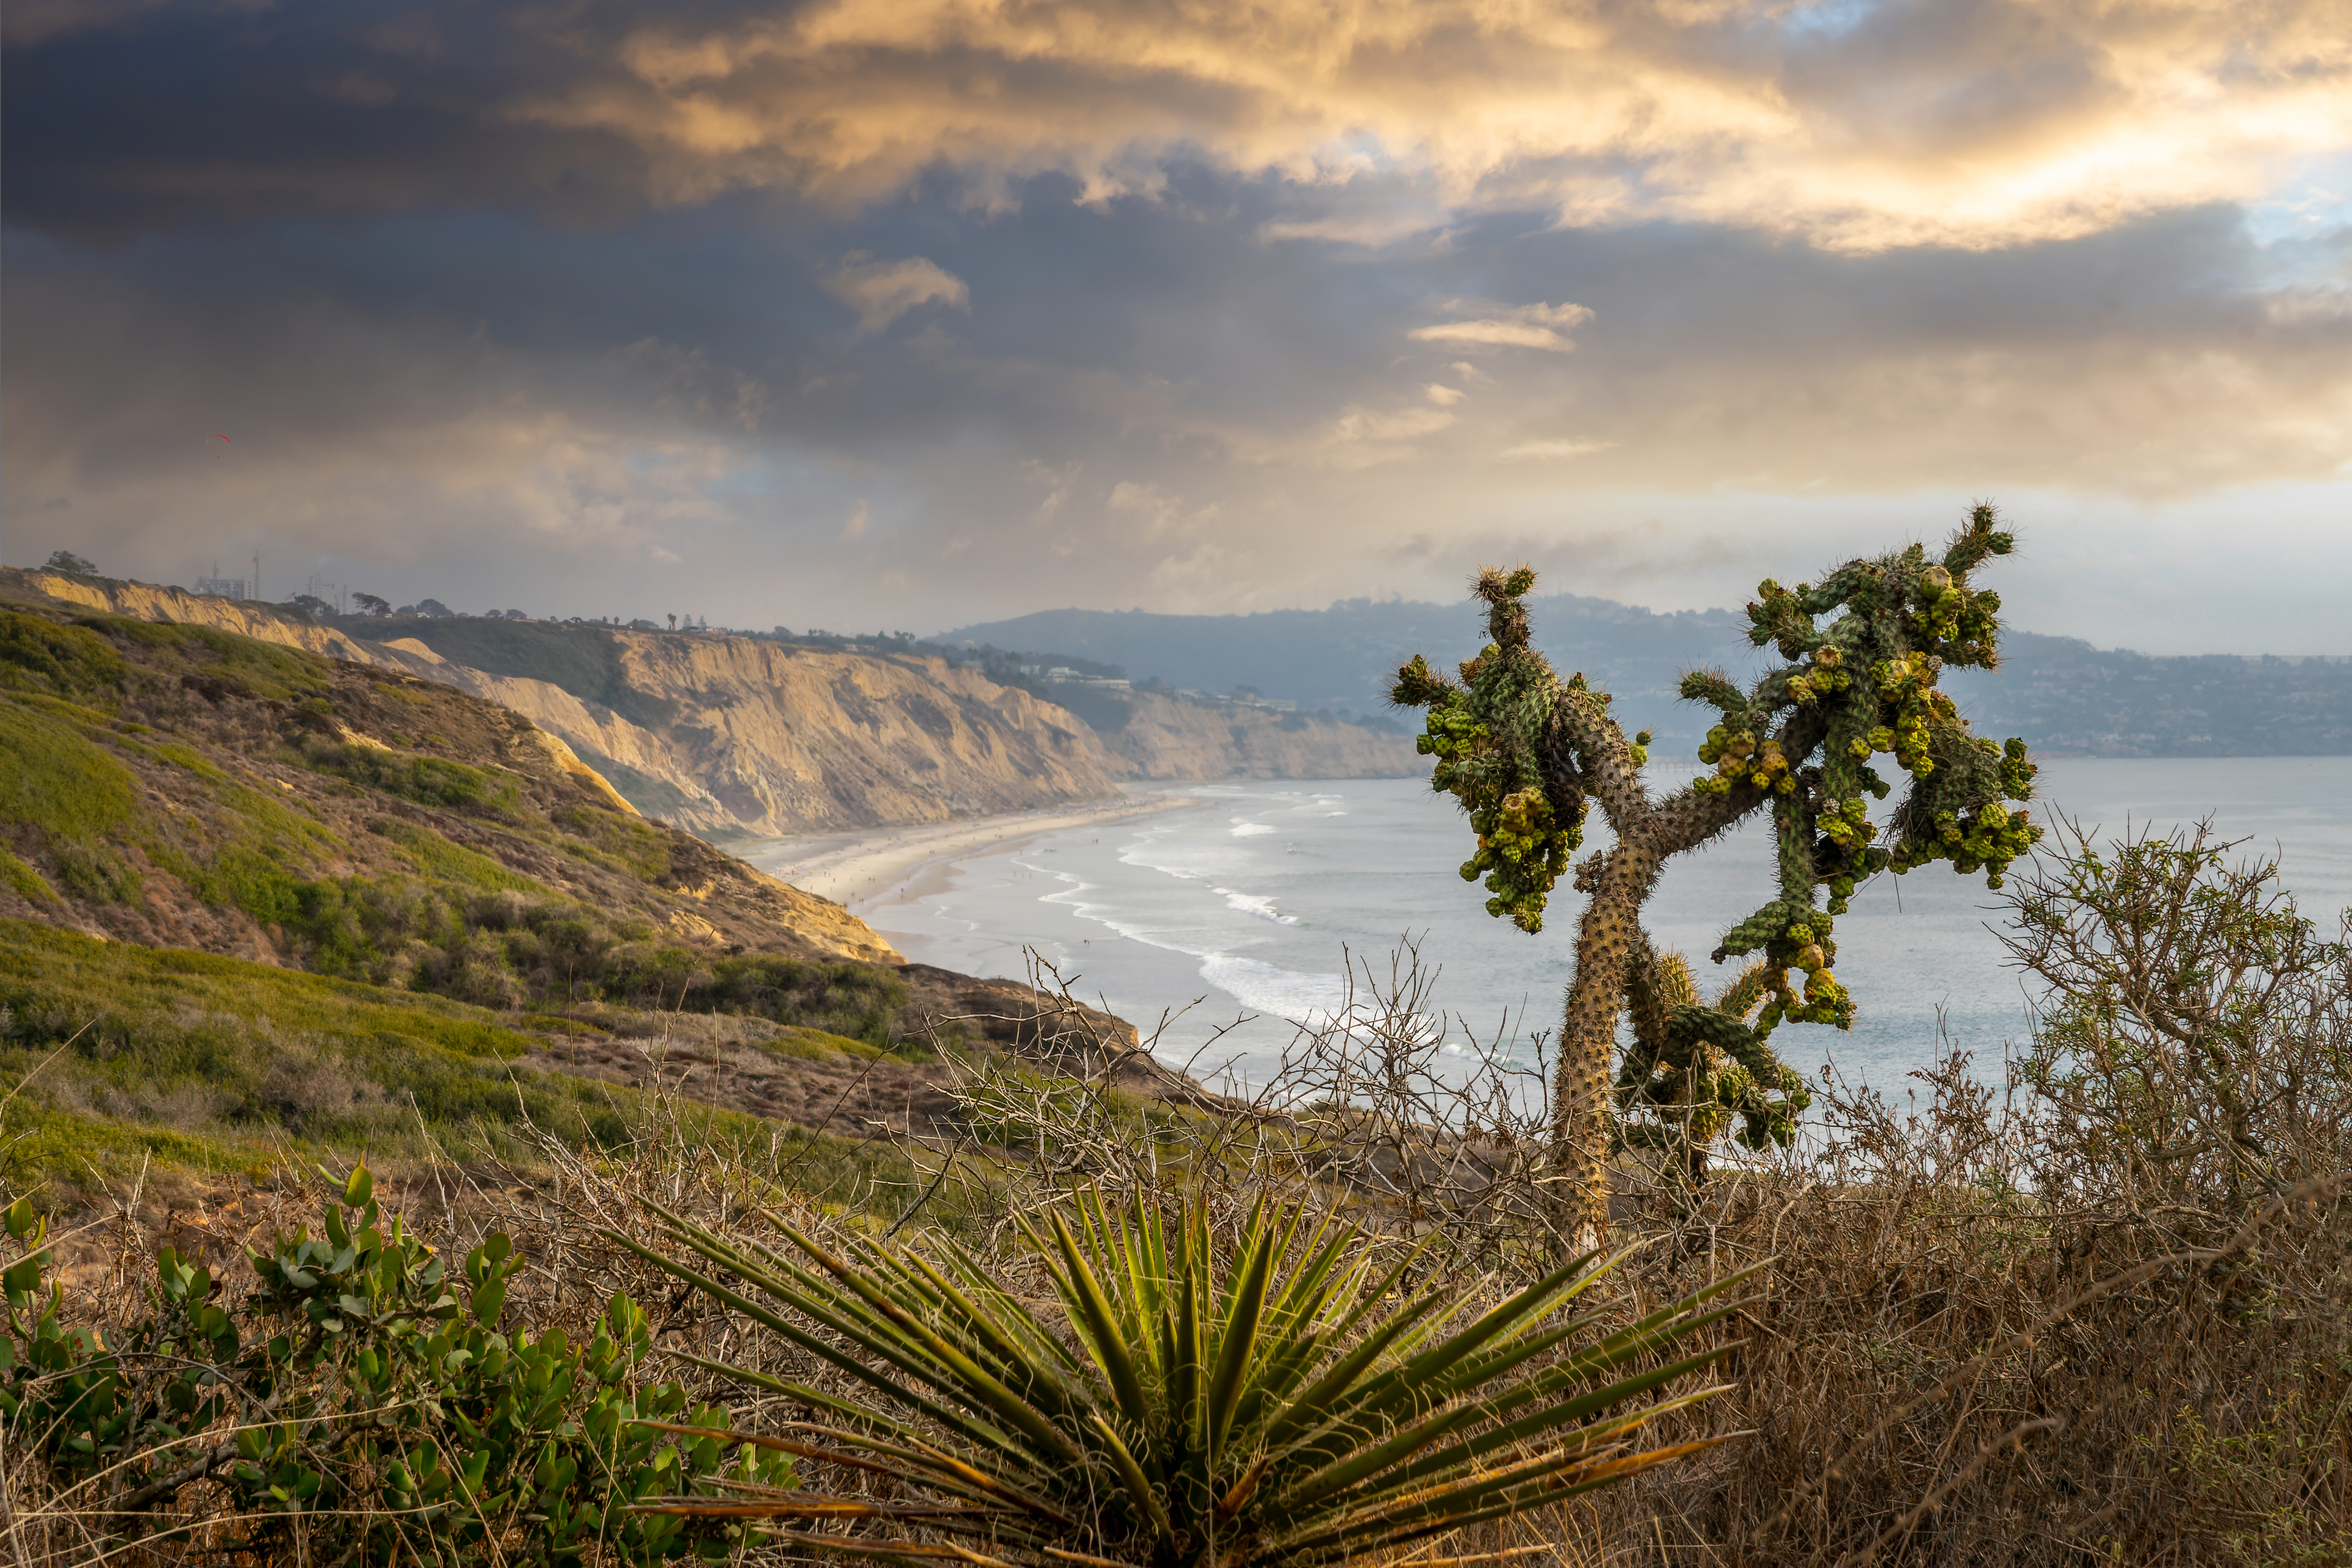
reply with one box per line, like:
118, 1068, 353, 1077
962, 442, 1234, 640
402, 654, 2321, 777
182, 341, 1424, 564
936, 595, 2352, 757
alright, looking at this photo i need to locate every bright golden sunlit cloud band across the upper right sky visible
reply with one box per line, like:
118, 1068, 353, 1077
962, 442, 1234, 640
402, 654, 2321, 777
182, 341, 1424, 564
508, 0, 2352, 252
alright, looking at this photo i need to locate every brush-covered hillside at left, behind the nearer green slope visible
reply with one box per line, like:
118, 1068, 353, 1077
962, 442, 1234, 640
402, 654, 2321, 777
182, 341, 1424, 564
0, 573, 896, 968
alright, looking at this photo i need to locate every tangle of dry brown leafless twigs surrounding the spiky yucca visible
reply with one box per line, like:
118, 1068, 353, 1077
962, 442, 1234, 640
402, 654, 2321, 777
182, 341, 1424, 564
0, 828, 2352, 1568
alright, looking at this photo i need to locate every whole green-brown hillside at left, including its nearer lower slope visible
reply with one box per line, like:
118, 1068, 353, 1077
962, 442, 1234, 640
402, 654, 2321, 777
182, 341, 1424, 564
0, 583, 1197, 1201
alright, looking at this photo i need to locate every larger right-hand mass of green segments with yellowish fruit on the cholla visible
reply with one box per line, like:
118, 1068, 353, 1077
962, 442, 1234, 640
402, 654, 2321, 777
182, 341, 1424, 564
1682, 505, 2042, 1032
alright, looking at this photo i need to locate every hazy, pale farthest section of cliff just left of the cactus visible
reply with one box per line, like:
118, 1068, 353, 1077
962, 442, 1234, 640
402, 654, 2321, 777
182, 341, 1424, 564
1096, 691, 1430, 780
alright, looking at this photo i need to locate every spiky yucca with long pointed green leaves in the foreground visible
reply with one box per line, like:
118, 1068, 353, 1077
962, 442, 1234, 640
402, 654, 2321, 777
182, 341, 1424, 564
614, 1194, 1745, 1568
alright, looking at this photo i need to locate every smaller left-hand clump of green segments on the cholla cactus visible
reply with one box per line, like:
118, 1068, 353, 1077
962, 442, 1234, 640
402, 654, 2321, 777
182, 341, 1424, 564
1390, 566, 1585, 933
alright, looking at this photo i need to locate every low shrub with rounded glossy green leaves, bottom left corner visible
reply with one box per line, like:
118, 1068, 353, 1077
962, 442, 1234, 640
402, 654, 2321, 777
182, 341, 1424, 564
0, 1166, 793, 1563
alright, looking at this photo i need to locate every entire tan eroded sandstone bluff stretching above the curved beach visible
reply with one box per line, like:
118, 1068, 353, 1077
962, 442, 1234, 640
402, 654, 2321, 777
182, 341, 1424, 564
16, 571, 1423, 837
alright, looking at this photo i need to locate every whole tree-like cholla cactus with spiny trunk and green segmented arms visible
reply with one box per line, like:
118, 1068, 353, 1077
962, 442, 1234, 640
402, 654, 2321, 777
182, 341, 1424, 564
1390, 505, 2042, 1236
